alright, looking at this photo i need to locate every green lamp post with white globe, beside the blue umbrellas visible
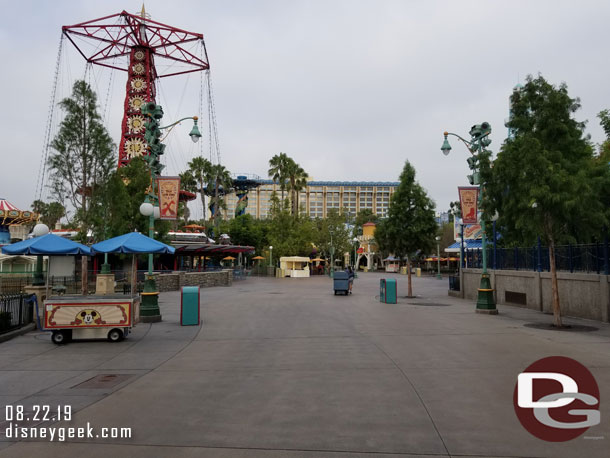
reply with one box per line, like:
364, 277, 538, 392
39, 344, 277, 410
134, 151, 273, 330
140, 102, 201, 323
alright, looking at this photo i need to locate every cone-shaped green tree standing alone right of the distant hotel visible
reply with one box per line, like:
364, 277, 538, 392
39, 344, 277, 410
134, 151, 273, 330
375, 161, 438, 296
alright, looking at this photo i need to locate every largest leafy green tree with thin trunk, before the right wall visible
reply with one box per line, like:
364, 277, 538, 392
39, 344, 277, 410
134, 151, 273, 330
481, 75, 603, 326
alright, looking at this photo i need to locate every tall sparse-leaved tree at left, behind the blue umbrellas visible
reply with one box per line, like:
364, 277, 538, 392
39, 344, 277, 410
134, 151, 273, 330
48, 81, 116, 240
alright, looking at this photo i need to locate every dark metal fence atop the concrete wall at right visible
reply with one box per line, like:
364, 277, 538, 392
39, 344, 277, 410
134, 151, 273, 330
464, 240, 610, 275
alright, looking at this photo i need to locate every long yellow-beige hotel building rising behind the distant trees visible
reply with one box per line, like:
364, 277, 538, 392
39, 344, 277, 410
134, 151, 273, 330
225, 180, 399, 218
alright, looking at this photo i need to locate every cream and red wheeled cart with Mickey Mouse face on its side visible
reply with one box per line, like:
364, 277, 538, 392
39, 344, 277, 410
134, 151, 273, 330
43, 294, 140, 344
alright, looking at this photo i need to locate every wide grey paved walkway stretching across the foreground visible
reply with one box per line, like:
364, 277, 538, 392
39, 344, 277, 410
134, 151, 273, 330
0, 273, 610, 458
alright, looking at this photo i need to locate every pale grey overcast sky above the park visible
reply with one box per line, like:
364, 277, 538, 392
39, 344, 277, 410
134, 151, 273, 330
0, 0, 610, 220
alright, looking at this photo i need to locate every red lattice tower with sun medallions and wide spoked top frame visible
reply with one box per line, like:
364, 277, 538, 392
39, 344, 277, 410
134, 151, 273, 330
62, 7, 210, 167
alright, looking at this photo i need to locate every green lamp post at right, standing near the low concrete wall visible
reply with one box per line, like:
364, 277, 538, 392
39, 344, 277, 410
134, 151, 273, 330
441, 122, 498, 315
